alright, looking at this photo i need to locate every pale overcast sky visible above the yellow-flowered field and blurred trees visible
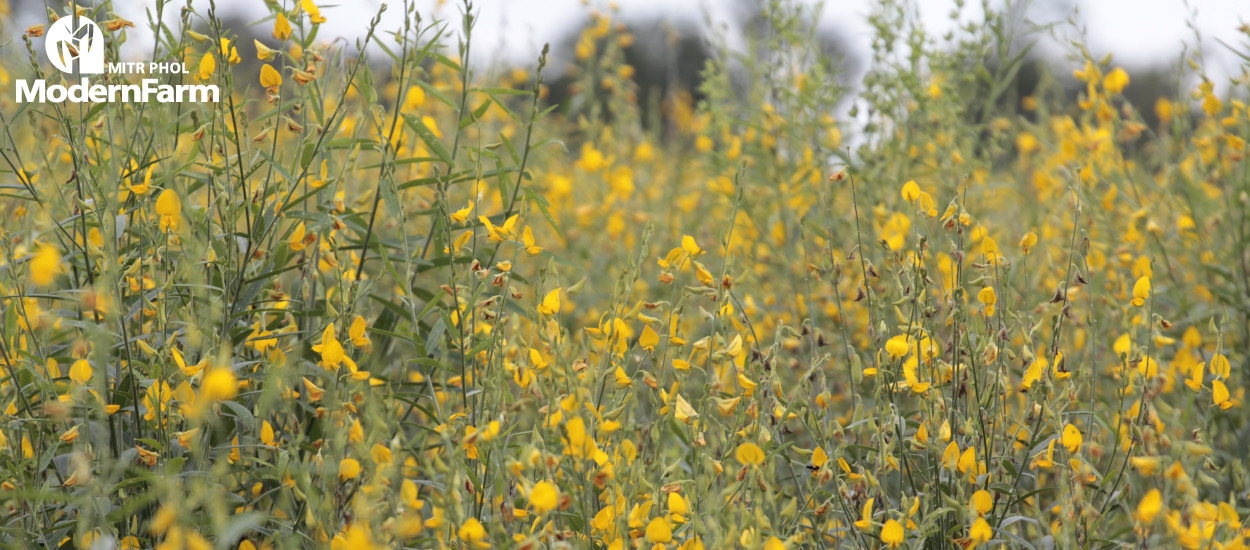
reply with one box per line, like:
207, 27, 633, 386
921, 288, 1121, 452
95, 0, 1250, 84
